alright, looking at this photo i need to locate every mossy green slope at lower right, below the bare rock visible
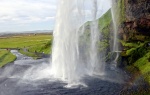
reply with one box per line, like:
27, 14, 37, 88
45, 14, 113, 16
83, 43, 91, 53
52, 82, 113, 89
125, 41, 150, 83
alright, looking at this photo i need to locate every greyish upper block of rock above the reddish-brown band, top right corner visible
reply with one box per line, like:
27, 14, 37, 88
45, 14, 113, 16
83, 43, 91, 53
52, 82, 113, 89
125, 0, 150, 21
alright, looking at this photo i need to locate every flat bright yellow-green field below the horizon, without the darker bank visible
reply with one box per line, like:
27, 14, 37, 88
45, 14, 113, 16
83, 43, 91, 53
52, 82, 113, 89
0, 34, 52, 48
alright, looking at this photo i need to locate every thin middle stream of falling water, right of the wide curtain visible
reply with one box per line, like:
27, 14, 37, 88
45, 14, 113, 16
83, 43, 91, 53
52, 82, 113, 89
90, 0, 105, 74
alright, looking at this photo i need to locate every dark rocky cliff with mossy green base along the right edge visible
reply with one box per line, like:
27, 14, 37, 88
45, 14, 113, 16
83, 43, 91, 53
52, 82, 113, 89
118, 0, 150, 83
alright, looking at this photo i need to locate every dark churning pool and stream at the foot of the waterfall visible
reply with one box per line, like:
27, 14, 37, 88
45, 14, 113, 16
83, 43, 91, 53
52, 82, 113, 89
0, 50, 148, 95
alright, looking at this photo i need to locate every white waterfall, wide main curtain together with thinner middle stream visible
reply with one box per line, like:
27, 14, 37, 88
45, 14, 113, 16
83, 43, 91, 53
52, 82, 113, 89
51, 0, 111, 84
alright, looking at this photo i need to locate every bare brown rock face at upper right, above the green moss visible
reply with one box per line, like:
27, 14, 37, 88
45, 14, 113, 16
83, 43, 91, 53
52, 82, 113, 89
122, 0, 150, 41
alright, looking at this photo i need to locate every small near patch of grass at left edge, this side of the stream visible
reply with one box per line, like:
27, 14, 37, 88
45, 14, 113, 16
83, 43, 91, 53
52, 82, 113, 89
0, 50, 16, 67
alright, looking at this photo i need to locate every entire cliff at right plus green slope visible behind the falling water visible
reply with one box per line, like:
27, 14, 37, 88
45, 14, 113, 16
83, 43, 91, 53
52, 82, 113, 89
81, 0, 150, 83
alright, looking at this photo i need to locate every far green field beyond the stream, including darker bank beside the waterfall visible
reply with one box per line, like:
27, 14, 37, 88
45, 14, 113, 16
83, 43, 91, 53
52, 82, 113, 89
0, 34, 53, 54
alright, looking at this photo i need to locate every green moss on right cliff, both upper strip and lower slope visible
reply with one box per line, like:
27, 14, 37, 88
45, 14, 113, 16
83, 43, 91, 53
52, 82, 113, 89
111, 0, 150, 84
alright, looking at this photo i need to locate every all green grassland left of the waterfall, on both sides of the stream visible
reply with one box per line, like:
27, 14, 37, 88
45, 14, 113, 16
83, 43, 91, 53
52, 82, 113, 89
0, 34, 53, 67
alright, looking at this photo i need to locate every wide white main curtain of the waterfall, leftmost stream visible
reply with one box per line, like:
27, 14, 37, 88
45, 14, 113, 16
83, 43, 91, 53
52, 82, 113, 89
52, 0, 84, 83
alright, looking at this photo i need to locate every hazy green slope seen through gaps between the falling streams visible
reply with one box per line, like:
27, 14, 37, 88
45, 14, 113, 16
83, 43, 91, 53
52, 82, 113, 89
80, 10, 112, 59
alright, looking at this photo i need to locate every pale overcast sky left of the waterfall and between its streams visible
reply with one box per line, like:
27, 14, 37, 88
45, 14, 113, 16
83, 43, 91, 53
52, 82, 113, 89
0, 0, 109, 32
